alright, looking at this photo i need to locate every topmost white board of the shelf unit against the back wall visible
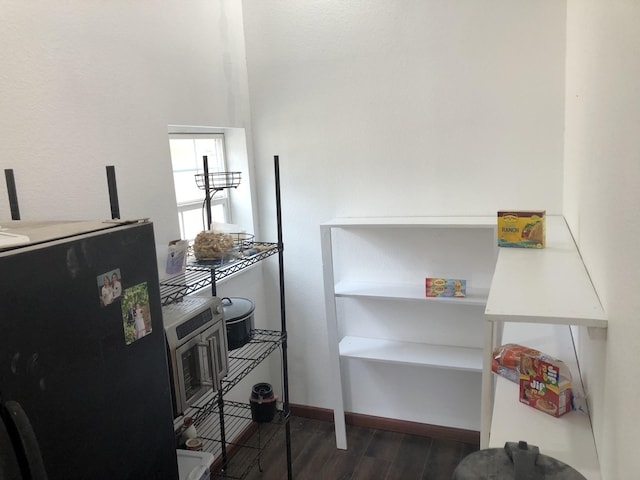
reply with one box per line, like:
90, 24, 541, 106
321, 216, 498, 229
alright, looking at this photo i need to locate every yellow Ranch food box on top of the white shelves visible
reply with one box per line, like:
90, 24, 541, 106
498, 210, 546, 248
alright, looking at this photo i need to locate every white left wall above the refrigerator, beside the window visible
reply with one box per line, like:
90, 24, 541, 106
0, 0, 255, 262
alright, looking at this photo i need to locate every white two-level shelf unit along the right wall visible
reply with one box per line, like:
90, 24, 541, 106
481, 216, 607, 480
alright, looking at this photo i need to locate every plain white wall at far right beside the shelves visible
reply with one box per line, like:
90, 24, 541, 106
564, 0, 640, 480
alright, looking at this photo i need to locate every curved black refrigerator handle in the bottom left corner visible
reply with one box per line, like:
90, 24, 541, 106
1, 400, 47, 480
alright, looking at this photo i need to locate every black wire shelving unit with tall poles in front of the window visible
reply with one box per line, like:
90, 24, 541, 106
160, 156, 293, 480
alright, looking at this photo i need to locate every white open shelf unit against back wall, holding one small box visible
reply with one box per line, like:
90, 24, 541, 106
320, 216, 497, 448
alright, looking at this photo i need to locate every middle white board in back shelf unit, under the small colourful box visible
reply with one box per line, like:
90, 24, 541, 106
335, 281, 489, 306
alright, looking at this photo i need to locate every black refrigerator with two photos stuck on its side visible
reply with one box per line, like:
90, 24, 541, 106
0, 221, 178, 480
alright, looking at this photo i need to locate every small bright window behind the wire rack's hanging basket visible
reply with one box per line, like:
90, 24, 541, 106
169, 133, 231, 240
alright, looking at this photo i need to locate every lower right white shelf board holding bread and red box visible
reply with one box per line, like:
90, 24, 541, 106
489, 323, 602, 480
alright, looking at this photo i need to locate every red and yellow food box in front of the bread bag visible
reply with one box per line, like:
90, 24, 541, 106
520, 354, 571, 417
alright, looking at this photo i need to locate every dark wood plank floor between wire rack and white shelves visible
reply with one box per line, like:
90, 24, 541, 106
238, 417, 478, 480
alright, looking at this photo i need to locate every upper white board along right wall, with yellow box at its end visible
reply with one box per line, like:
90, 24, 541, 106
485, 216, 607, 328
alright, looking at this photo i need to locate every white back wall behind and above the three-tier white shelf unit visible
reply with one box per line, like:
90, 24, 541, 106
243, 0, 566, 428
